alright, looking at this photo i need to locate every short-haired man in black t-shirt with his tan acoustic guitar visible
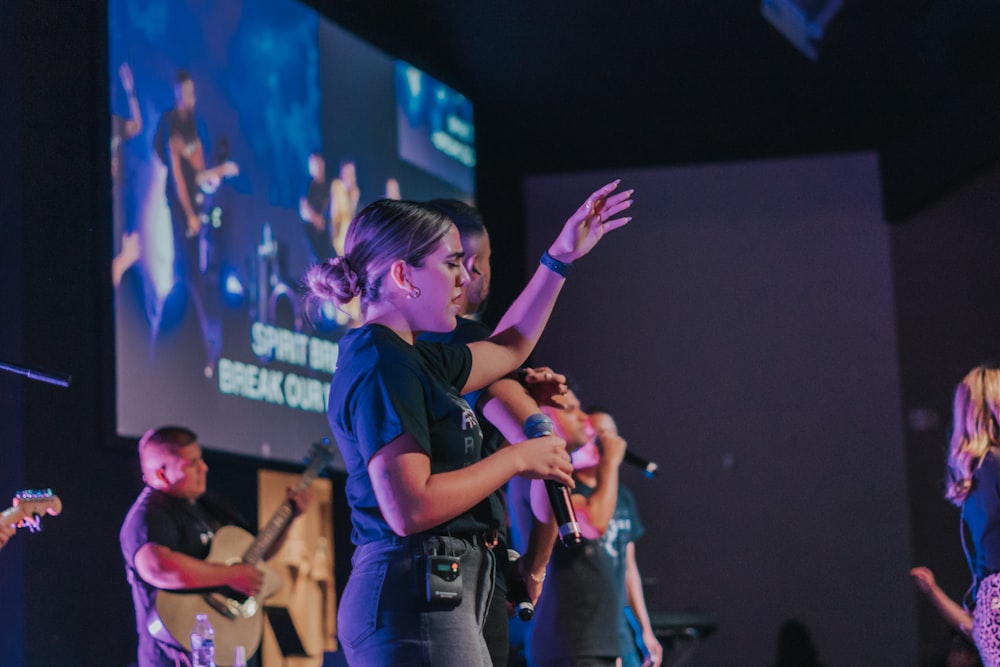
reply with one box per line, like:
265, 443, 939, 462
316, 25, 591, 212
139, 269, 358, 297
120, 426, 311, 667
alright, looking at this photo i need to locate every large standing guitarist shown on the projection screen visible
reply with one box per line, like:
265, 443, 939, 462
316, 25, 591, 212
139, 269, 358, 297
155, 70, 240, 377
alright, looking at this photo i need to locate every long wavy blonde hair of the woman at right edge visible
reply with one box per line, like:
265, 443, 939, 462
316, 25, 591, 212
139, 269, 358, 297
944, 366, 1000, 506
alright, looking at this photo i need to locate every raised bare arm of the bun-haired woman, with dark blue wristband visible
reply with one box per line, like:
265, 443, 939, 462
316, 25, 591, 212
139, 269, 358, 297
462, 180, 632, 393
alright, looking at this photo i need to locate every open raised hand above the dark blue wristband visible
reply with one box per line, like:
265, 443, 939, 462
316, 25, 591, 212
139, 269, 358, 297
549, 179, 633, 264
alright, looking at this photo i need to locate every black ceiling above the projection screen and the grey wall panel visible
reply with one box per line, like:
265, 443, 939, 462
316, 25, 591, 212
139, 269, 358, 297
310, 0, 1000, 220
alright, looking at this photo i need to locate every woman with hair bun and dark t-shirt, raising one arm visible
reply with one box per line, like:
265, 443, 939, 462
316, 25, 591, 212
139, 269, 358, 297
306, 181, 632, 667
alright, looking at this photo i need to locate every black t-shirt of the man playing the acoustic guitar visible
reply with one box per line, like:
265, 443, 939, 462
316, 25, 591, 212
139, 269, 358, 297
119, 486, 253, 667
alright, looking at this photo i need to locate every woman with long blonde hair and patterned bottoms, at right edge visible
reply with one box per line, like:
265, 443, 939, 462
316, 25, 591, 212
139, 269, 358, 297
945, 366, 1000, 667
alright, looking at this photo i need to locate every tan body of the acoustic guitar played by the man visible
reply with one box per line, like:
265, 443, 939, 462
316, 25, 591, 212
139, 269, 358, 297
154, 526, 281, 667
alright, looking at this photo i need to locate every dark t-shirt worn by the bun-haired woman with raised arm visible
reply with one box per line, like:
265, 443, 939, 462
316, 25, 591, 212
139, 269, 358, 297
328, 324, 490, 545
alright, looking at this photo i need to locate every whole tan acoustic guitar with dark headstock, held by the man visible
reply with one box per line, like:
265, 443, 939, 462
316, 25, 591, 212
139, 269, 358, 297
149, 440, 333, 667
